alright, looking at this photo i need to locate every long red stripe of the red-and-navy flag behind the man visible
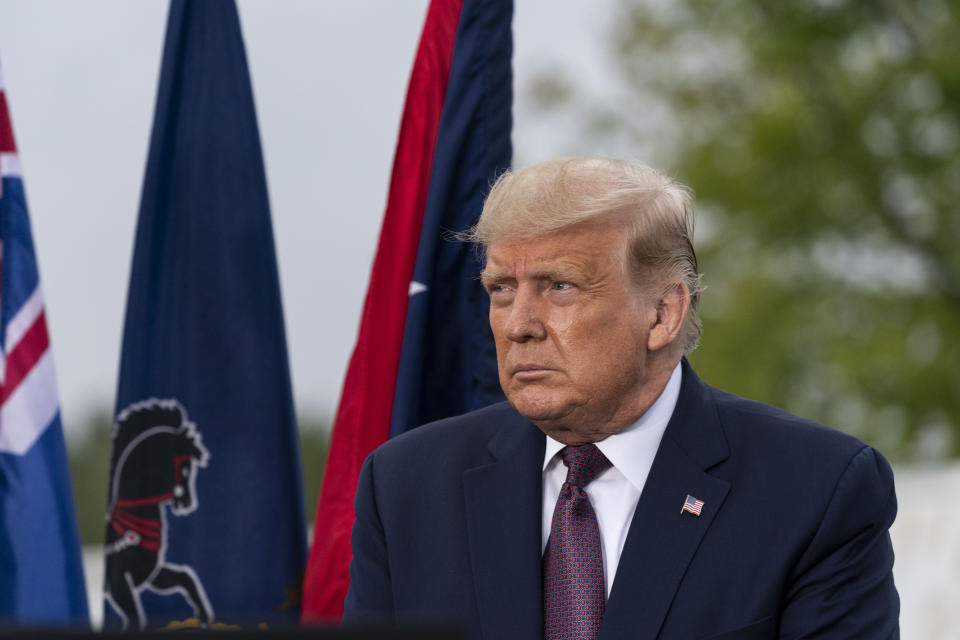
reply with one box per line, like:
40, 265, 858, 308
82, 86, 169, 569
303, 0, 462, 622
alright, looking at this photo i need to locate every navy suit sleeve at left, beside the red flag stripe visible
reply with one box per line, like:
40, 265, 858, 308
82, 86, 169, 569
343, 454, 393, 623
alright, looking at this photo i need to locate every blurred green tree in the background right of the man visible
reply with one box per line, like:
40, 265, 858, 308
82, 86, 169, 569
541, 0, 960, 460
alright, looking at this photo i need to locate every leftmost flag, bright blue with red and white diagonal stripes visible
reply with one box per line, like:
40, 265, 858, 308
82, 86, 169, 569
0, 61, 89, 626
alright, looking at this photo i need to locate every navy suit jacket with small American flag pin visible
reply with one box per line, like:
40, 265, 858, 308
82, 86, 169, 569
344, 361, 899, 640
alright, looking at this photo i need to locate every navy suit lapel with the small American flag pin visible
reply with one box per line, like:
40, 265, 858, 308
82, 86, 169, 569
600, 360, 730, 639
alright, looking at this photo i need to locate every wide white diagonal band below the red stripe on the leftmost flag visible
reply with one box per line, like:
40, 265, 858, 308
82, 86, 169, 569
0, 349, 59, 455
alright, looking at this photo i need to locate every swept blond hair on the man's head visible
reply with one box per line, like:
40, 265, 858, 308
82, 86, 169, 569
461, 157, 703, 353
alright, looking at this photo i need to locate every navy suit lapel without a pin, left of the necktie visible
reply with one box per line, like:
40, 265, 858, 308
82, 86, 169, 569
463, 415, 544, 638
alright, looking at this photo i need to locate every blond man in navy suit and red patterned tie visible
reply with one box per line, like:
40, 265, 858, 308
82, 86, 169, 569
345, 158, 899, 640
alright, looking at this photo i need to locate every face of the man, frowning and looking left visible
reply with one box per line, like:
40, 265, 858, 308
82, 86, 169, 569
483, 224, 659, 444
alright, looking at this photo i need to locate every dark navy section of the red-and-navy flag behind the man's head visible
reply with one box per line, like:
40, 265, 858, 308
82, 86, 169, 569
390, 0, 513, 436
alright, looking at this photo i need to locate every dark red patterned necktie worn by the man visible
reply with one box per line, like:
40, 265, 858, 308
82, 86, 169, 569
543, 444, 610, 640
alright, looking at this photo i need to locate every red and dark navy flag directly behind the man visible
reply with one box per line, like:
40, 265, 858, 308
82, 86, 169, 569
304, 0, 513, 621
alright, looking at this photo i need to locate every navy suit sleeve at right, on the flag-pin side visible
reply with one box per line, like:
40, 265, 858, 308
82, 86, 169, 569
780, 447, 900, 640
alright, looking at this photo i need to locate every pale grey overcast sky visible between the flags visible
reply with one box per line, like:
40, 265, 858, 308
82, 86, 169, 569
0, 0, 612, 432
